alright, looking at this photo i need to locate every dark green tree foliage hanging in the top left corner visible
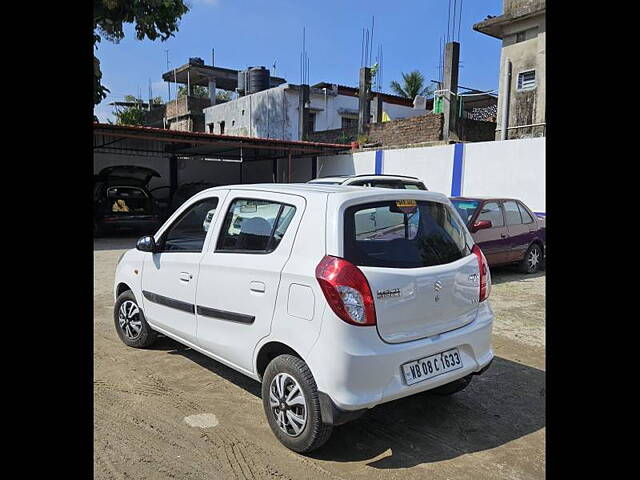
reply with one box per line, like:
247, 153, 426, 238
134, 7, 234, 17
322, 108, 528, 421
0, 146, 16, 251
93, 0, 189, 105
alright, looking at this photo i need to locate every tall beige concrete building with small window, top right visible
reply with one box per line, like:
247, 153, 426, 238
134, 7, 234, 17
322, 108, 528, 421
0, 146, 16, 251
473, 0, 546, 140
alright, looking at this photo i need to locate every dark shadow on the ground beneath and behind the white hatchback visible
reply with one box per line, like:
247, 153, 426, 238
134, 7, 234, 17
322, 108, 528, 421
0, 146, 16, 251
152, 337, 545, 469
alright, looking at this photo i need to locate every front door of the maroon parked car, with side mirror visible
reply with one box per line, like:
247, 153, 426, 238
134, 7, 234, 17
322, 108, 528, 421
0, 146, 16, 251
473, 201, 511, 265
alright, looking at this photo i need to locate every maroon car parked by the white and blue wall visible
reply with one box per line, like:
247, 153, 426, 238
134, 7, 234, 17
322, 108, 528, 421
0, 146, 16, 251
451, 197, 546, 273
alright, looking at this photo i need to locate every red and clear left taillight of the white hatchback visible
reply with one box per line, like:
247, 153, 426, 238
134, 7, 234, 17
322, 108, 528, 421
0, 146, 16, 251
316, 255, 376, 326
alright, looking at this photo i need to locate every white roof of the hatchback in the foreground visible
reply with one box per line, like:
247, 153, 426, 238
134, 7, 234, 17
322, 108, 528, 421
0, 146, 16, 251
201, 183, 447, 201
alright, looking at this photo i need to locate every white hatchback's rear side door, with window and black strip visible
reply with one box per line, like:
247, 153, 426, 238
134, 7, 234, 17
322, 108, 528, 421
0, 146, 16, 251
196, 191, 305, 371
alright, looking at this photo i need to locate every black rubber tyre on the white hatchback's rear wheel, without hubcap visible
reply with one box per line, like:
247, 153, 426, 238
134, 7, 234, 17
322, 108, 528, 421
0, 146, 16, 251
262, 355, 333, 453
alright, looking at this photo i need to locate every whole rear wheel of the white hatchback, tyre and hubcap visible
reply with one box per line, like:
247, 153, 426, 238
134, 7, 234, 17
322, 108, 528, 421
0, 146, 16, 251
262, 355, 333, 453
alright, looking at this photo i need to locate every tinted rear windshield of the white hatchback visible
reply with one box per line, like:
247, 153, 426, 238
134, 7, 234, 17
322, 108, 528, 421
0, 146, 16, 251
344, 200, 471, 268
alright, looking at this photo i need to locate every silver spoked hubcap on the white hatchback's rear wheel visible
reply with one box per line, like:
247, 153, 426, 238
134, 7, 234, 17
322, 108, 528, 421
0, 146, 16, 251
269, 373, 307, 437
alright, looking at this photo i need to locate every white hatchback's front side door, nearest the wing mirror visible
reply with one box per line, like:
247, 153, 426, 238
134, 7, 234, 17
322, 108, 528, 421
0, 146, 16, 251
142, 196, 225, 342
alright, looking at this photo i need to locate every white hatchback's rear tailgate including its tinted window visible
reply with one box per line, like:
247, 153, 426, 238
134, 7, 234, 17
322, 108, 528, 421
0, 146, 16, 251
344, 200, 480, 343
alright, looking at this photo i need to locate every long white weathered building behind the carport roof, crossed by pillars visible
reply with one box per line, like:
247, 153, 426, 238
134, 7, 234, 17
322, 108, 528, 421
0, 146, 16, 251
203, 82, 432, 140
